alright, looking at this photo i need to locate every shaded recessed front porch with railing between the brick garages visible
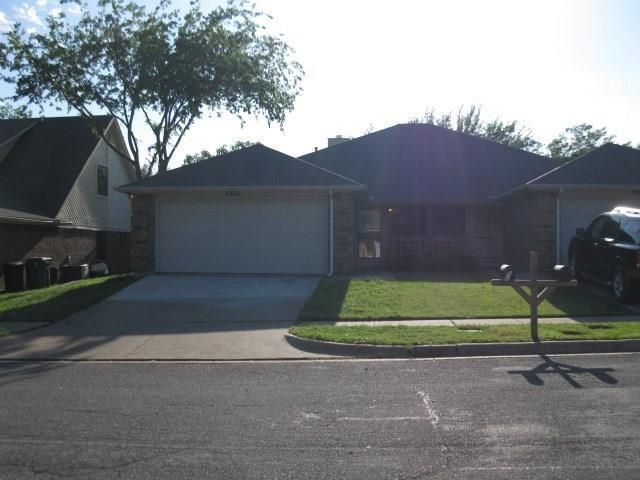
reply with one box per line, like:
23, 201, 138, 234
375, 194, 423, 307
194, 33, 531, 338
355, 202, 502, 271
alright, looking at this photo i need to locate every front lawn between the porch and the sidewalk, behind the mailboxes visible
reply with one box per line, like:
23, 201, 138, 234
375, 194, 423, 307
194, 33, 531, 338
298, 278, 629, 321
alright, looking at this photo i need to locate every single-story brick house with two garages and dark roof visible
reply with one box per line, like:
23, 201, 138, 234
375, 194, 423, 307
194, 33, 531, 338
120, 124, 640, 274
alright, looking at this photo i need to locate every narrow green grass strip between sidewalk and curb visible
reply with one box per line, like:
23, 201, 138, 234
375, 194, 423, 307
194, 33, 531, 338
289, 322, 640, 345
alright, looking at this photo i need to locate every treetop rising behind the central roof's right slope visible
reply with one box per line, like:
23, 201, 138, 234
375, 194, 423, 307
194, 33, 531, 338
410, 105, 542, 153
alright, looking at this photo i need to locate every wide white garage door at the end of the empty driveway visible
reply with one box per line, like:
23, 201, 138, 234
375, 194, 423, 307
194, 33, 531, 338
156, 198, 329, 273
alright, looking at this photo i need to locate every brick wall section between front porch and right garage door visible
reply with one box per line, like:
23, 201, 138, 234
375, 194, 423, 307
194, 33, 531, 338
504, 191, 556, 270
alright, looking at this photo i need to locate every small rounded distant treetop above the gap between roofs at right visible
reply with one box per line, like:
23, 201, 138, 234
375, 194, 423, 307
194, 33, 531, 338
547, 123, 616, 161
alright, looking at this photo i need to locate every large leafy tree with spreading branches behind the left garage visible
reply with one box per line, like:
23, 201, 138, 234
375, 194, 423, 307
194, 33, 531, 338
0, 0, 302, 177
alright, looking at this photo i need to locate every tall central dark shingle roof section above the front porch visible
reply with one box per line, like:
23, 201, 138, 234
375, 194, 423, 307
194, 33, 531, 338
301, 124, 558, 202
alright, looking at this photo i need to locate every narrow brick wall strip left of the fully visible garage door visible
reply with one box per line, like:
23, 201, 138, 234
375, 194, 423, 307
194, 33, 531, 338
131, 195, 156, 272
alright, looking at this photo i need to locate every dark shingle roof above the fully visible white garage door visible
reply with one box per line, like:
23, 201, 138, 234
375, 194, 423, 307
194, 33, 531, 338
120, 144, 359, 192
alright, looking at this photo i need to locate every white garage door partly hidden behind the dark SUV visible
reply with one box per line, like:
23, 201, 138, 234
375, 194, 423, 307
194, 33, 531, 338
560, 197, 640, 265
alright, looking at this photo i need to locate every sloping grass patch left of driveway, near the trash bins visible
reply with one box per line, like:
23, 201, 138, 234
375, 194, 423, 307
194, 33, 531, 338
0, 275, 136, 322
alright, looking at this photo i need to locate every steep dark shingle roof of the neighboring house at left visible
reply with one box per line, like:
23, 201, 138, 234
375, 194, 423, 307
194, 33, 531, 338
0, 116, 112, 217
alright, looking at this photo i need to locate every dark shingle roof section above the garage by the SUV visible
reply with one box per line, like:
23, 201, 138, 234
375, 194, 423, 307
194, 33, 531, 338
527, 143, 640, 186
